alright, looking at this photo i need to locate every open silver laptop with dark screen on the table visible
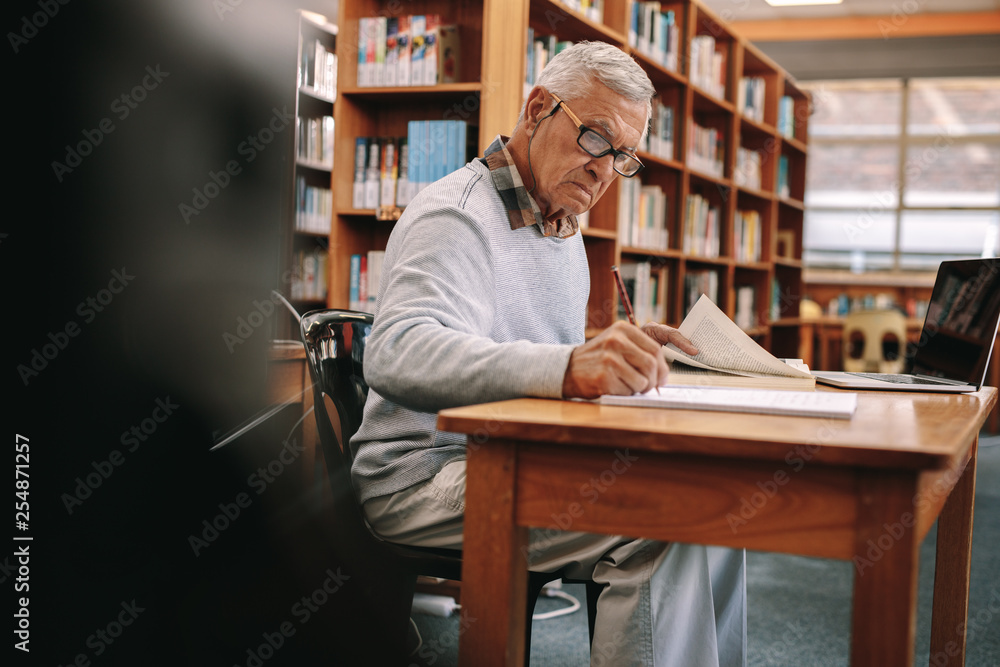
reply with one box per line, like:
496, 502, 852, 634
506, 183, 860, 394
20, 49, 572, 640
812, 257, 1000, 393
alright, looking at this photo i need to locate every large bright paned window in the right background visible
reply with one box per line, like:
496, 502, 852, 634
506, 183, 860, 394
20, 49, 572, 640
801, 78, 1000, 271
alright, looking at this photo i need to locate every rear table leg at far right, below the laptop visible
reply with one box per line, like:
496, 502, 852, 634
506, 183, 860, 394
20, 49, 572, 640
930, 438, 979, 667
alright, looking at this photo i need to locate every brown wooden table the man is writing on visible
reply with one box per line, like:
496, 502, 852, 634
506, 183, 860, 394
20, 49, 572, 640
438, 387, 997, 667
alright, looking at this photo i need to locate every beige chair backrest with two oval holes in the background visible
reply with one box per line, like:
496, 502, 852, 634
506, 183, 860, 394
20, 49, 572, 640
843, 310, 906, 373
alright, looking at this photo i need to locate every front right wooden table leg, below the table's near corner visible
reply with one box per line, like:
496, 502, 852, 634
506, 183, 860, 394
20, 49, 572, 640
851, 473, 919, 667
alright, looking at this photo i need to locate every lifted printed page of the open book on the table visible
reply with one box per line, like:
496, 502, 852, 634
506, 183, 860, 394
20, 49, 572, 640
663, 294, 812, 378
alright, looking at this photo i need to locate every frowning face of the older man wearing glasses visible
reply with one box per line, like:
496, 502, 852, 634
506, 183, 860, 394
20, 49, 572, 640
525, 82, 646, 219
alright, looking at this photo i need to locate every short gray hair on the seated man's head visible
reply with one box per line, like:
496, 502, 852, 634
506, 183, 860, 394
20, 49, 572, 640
518, 41, 656, 139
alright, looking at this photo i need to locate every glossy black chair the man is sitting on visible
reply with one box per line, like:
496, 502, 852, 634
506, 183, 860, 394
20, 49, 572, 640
300, 310, 601, 665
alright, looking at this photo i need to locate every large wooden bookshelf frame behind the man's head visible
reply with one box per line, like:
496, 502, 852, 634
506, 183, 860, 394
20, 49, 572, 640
327, 0, 810, 357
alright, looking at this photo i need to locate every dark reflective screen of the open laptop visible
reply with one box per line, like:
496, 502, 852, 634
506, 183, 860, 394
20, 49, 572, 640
906, 257, 1000, 388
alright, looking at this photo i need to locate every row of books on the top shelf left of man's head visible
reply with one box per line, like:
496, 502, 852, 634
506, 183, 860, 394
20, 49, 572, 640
358, 14, 461, 87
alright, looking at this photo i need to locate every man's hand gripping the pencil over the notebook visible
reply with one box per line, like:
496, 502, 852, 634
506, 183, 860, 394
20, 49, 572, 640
563, 321, 669, 398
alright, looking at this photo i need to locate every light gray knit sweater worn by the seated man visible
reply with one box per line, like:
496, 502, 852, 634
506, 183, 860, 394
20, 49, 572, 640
351, 144, 590, 502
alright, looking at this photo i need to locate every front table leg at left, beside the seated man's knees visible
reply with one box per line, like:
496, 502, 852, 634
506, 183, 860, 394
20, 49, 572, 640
458, 436, 528, 667
